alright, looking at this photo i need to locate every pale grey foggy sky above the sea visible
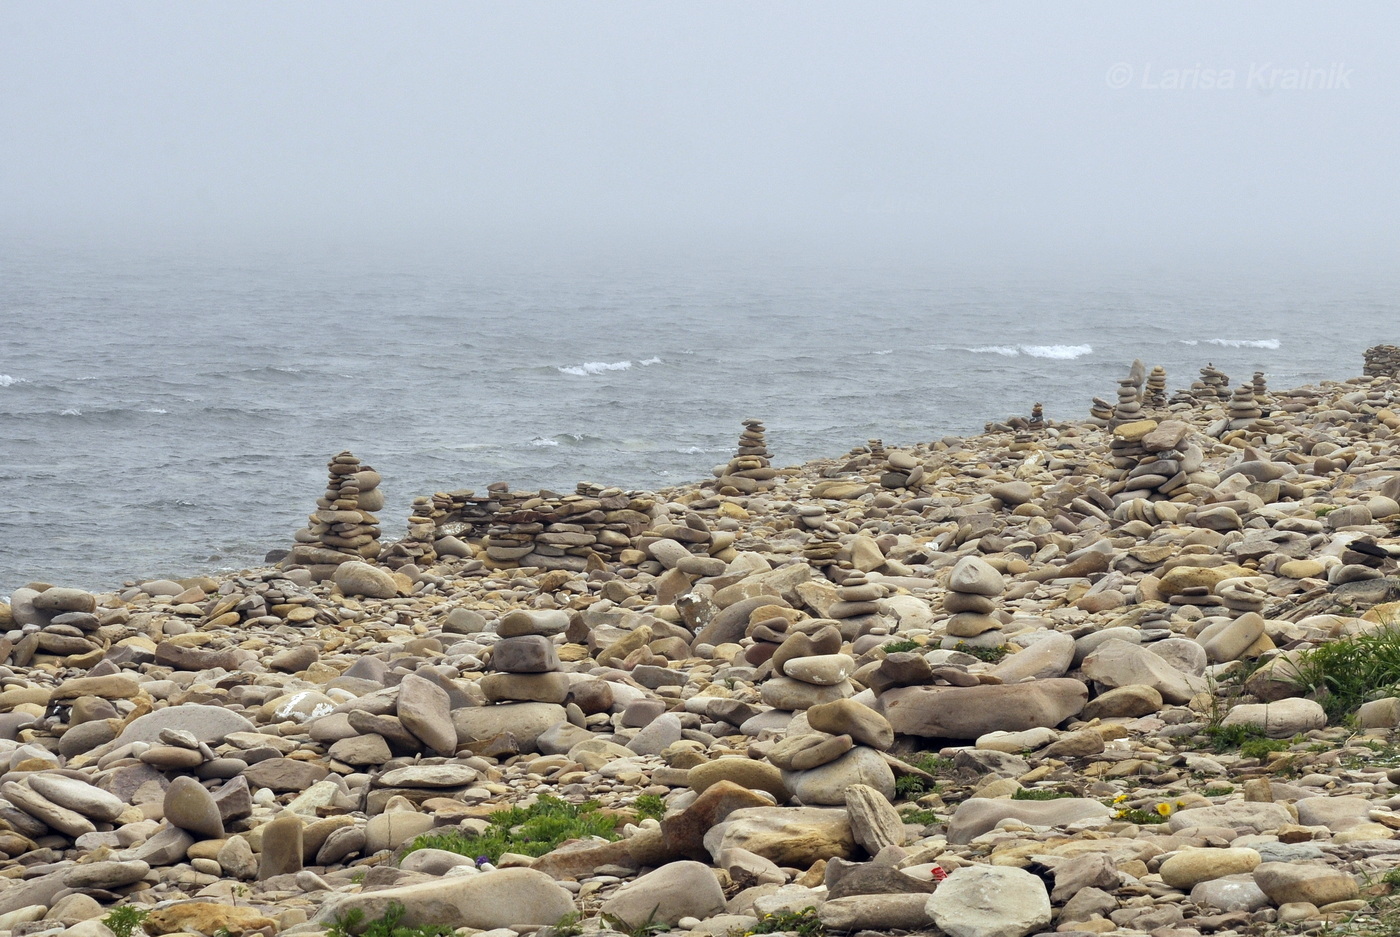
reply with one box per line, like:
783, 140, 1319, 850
0, 0, 1400, 263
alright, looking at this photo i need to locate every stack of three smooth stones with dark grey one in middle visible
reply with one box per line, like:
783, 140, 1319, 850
477, 609, 568, 705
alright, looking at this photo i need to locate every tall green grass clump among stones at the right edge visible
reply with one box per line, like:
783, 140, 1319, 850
1294, 623, 1400, 723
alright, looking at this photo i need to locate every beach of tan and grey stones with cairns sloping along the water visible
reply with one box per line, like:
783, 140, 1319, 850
8, 346, 1400, 937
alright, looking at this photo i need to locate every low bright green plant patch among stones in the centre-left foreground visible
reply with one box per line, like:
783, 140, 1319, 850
403, 794, 622, 863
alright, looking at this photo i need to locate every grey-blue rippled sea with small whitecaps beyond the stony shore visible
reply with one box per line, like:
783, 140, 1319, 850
0, 248, 1400, 595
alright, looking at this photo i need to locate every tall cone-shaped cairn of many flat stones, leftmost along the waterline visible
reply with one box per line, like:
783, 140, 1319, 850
286, 451, 384, 578
